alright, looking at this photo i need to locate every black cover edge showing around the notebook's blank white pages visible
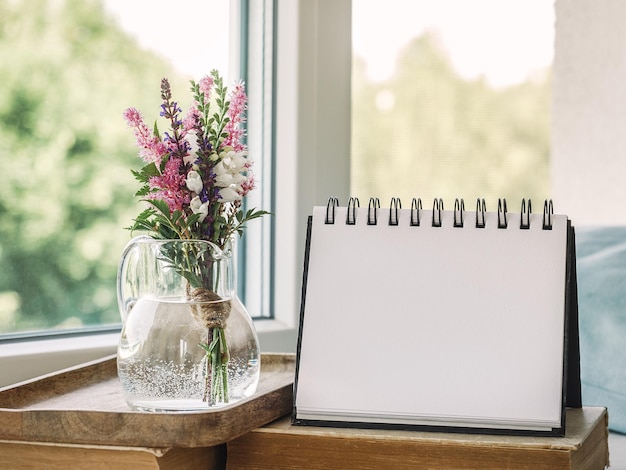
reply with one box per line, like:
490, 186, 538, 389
291, 216, 582, 437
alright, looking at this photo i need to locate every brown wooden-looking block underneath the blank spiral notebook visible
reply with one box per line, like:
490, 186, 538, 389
227, 408, 608, 470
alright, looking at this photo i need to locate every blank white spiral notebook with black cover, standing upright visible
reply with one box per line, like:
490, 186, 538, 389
292, 198, 581, 435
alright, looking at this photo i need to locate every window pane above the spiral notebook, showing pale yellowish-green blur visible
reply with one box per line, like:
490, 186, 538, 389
351, 0, 554, 210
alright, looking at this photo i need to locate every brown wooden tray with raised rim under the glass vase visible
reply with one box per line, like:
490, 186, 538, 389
0, 354, 295, 448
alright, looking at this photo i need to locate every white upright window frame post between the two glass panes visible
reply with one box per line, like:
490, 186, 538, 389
257, 0, 352, 351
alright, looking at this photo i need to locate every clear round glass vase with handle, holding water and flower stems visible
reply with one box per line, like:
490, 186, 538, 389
117, 236, 261, 412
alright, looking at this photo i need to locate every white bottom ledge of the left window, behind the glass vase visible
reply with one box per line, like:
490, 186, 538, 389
0, 320, 297, 387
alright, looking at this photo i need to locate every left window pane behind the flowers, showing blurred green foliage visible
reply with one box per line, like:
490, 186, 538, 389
0, 0, 229, 333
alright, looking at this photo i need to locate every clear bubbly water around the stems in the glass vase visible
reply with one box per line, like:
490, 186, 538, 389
118, 299, 260, 411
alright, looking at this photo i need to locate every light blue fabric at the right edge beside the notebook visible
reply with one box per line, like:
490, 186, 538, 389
576, 227, 626, 433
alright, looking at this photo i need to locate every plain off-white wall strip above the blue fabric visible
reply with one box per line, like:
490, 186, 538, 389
552, 0, 626, 226
